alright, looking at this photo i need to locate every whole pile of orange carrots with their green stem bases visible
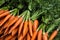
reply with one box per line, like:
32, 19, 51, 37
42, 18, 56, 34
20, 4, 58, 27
0, 9, 60, 40
